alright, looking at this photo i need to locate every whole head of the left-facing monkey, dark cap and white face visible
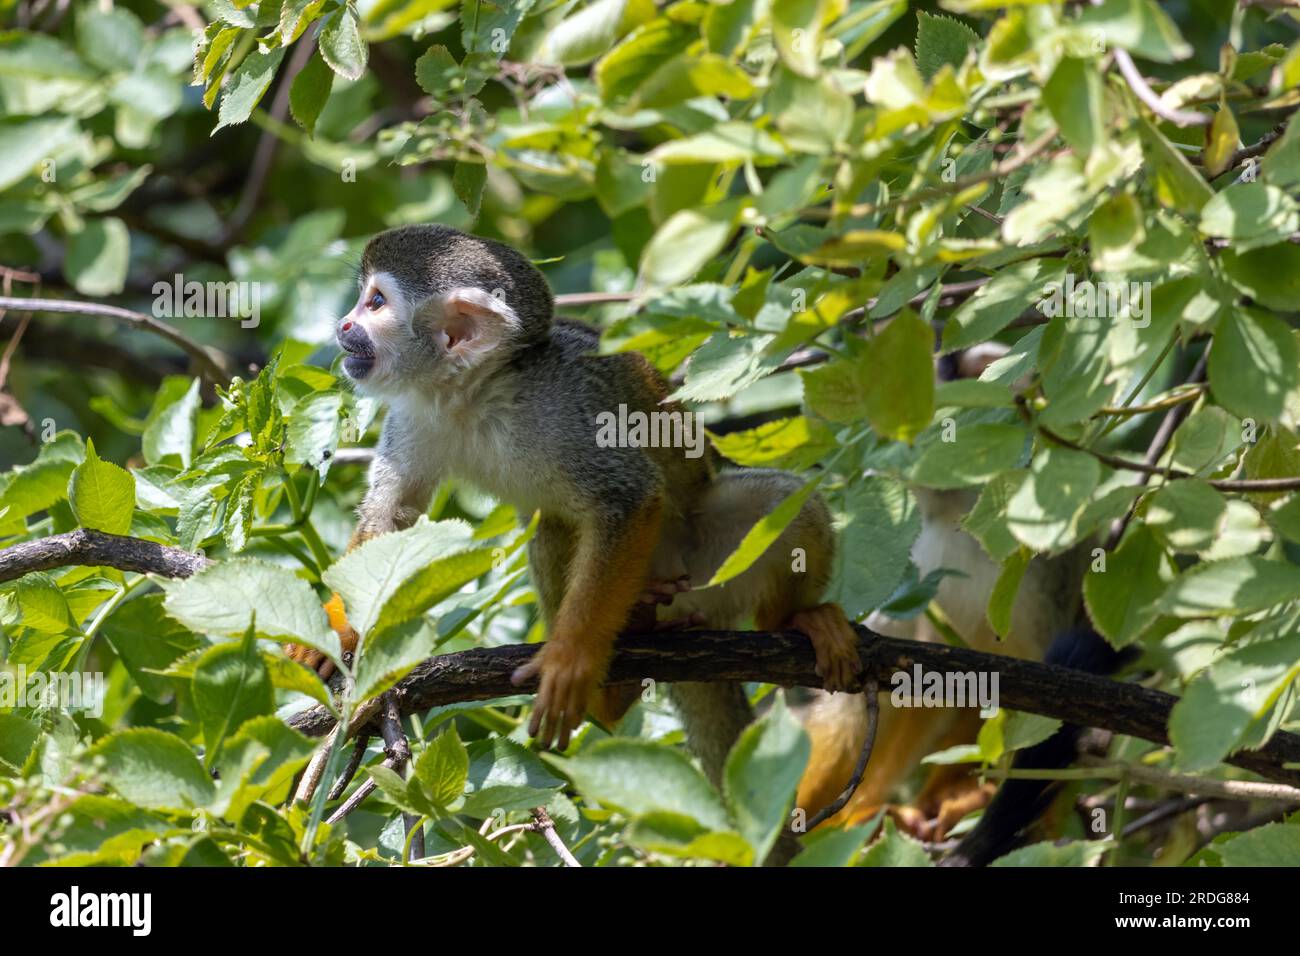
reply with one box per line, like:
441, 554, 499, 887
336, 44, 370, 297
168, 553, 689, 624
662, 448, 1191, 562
337, 225, 553, 397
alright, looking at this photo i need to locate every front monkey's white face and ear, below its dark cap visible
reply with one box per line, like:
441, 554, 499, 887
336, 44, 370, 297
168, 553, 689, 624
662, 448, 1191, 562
335, 272, 520, 397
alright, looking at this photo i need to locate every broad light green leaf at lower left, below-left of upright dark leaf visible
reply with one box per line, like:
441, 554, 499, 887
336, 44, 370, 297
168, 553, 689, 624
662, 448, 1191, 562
90, 727, 216, 810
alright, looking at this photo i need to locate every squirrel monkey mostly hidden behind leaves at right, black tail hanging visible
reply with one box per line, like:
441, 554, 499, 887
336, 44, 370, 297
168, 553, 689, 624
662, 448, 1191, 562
797, 343, 1121, 865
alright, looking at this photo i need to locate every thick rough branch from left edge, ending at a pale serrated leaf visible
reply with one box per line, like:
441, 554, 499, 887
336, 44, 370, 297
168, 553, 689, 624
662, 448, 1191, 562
0, 529, 211, 581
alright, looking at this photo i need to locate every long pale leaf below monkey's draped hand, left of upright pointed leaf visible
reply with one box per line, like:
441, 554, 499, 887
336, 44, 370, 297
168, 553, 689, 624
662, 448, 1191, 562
556, 737, 729, 831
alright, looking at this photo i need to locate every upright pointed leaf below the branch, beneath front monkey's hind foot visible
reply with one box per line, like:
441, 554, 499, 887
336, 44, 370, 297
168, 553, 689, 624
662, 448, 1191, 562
723, 692, 813, 860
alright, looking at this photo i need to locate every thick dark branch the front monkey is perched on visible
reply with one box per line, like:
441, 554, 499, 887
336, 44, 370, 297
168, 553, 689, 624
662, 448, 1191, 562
289, 626, 1300, 786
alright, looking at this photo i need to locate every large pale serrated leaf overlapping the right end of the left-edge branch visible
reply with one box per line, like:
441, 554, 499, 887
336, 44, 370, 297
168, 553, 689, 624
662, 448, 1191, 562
163, 551, 340, 661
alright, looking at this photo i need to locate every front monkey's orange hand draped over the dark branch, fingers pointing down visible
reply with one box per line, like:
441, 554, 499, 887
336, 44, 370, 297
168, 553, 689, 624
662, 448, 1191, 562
510, 639, 610, 750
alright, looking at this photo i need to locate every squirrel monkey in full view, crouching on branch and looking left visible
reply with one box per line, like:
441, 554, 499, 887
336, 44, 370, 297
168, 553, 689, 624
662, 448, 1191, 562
287, 225, 859, 754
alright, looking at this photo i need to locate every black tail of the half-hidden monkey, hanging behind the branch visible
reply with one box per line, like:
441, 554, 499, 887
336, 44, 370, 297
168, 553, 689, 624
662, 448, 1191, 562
939, 627, 1131, 866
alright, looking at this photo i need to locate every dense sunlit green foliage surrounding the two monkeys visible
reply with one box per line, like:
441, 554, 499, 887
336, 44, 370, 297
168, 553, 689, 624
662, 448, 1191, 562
0, 0, 1300, 865
